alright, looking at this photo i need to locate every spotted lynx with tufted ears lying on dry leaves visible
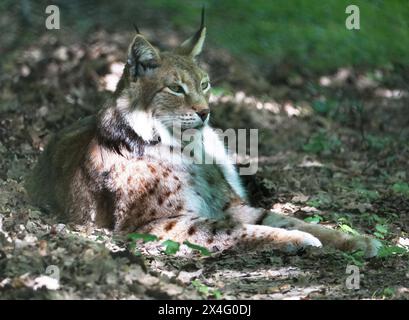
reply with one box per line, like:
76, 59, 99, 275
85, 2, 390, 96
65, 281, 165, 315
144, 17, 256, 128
27, 13, 379, 257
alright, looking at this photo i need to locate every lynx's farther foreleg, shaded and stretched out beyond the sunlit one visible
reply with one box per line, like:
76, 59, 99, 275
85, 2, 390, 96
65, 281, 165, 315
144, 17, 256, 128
262, 212, 381, 258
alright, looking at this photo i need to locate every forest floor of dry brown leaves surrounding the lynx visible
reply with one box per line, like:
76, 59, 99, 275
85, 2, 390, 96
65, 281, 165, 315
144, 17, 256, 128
0, 23, 409, 299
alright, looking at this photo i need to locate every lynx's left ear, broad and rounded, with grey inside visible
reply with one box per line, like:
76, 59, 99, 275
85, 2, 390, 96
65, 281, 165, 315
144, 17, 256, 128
127, 34, 160, 79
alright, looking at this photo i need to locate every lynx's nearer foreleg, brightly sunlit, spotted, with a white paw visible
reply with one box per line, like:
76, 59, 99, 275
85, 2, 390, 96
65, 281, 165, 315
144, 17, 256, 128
134, 215, 321, 252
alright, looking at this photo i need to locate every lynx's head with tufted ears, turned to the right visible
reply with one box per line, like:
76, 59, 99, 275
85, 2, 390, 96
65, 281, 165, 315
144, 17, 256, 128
116, 11, 210, 129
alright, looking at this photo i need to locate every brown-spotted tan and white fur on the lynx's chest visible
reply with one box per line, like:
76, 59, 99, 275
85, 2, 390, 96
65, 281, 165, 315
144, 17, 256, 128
83, 112, 245, 231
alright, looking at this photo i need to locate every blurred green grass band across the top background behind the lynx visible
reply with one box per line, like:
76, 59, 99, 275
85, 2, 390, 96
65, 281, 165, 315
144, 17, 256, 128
11, 0, 409, 73
